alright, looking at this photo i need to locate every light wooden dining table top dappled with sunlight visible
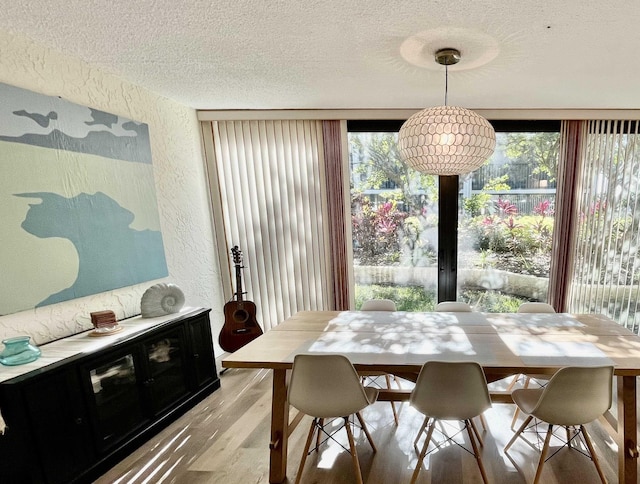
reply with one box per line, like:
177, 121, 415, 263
222, 311, 640, 376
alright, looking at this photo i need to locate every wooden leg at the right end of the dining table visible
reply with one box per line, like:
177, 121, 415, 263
617, 376, 638, 484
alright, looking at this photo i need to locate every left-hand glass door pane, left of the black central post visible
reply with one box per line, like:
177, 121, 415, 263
349, 123, 438, 311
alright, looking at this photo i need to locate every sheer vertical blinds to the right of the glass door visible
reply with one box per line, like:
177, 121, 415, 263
569, 120, 640, 333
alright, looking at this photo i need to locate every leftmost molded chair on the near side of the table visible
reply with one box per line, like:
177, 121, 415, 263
289, 354, 378, 484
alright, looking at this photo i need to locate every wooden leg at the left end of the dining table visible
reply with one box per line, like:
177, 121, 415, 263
269, 369, 289, 484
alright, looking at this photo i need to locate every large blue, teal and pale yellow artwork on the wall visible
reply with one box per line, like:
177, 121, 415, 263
0, 83, 168, 315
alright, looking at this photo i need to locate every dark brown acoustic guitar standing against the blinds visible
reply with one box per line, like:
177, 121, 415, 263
218, 245, 262, 353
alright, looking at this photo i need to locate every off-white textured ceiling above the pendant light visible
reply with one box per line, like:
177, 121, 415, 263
0, 0, 640, 109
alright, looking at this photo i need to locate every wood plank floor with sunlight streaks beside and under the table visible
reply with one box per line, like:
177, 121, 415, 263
96, 369, 636, 484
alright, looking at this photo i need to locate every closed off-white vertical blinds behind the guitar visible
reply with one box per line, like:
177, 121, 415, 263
203, 120, 333, 331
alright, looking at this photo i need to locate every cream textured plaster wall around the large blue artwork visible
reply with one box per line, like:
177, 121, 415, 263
0, 30, 223, 354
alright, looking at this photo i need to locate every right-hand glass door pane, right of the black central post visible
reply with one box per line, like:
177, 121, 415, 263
458, 123, 560, 312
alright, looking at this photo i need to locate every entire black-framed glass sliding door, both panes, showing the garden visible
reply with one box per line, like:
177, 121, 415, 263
349, 122, 559, 312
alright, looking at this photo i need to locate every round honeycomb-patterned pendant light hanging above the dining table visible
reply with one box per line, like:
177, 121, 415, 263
398, 49, 496, 175
